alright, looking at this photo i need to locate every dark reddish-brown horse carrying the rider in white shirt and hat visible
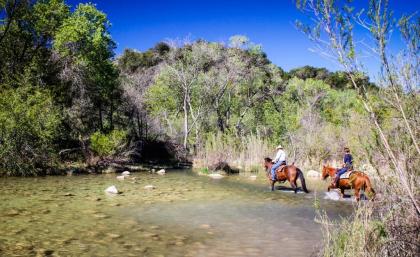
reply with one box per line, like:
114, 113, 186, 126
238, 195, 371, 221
264, 158, 309, 194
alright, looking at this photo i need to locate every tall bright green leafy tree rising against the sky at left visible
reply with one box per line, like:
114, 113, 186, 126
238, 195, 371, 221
53, 4, 120, 136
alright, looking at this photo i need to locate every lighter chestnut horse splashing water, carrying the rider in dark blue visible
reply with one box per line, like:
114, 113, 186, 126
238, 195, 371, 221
322, 165, 375, 201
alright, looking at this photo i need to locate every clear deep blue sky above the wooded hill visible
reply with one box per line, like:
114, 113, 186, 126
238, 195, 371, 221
67, 0, 420, 76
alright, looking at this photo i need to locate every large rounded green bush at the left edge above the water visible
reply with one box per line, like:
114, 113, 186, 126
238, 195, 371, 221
0, 85, 61, 176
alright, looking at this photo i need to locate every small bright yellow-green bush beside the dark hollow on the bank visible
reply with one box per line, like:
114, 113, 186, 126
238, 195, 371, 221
90, 130, 126, 157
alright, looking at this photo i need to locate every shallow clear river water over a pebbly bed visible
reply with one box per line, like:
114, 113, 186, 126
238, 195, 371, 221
0, 171, 352, 256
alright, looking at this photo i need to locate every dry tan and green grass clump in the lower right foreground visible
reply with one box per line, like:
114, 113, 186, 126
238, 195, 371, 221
318, 168, 420, 257
